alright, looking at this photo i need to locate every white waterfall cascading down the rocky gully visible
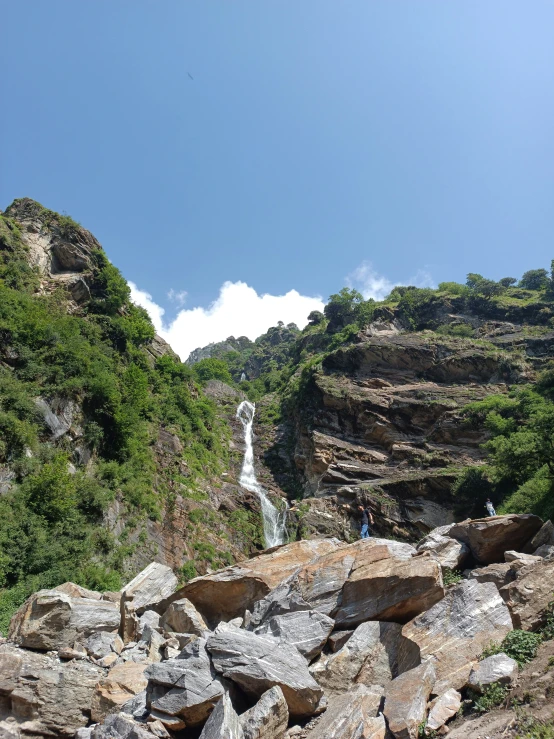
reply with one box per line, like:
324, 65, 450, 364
237, 400, 287, 547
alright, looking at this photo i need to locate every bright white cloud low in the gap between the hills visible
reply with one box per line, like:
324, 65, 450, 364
129, 282, 324, 360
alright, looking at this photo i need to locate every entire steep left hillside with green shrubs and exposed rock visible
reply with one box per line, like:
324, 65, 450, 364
0, 199, 262, 632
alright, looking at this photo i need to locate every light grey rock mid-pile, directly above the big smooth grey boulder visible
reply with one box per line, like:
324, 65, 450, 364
255, 611, 335, 660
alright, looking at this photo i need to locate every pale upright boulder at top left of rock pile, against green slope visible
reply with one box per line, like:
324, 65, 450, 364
120, 562, 178, 642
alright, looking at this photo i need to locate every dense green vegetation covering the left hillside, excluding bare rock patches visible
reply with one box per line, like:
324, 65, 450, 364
0, 206, 228, 629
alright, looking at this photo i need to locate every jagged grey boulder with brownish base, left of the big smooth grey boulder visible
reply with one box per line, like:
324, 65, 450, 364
144, 639, 225, 729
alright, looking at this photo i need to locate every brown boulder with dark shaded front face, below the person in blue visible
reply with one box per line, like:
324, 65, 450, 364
331, 555, 444, 628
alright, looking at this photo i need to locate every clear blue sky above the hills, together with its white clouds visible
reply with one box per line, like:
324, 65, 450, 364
0, 0, 554, 354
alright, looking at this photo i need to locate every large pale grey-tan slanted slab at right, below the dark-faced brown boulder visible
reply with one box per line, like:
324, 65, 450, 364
398, 580, 512, 695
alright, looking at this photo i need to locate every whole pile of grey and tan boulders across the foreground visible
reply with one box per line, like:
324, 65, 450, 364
0, 516, 554, 739
